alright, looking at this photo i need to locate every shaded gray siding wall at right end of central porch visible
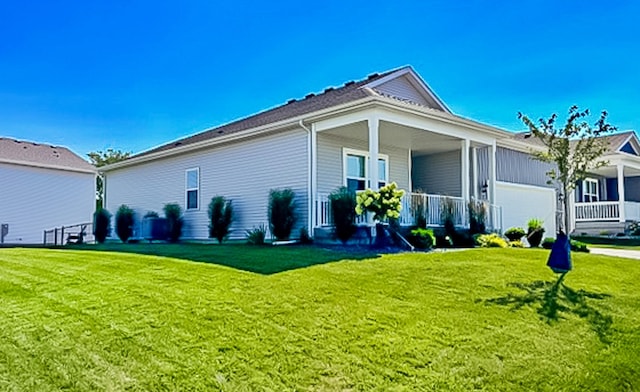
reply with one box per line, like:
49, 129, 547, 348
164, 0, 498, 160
413, 150, 462, 197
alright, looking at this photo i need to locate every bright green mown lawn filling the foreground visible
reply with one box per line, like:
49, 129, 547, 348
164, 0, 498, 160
0, 247, 640, 391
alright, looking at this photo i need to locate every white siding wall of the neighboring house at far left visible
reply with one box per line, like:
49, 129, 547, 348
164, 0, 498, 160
0, 163, 96, 244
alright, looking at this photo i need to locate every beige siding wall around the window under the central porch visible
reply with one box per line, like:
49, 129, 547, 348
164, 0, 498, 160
317, 133, 410, 194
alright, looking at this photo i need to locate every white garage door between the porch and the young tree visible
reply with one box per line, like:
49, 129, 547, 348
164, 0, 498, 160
496, 182, 556, 237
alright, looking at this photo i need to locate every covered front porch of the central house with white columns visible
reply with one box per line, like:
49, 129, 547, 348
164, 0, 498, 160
311, 105, 502, 231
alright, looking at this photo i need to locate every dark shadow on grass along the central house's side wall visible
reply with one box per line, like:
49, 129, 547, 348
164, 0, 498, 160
64, 243, 378, 275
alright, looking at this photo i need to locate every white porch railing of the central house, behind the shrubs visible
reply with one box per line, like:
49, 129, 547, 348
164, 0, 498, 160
315, 193, 502, 231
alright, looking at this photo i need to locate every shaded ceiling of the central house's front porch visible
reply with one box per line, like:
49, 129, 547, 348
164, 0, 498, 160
322, 121, 480, 156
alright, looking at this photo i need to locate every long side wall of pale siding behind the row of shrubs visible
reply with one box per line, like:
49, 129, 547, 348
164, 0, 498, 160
107, 129, 309, 239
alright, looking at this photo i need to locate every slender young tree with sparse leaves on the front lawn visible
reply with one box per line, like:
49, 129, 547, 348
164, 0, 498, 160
518, 106, 617, 231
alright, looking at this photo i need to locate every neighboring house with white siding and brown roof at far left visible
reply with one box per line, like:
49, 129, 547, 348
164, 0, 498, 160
0, 137, 96, 244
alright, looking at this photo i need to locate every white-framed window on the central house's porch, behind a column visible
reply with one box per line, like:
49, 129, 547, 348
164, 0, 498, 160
344, 148, 389, 191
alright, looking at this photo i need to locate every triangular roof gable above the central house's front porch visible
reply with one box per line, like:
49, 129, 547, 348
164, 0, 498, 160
365, 66, 451, 113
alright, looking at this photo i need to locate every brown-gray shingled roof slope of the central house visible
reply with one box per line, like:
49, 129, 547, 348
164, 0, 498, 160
132, 67, 405, 158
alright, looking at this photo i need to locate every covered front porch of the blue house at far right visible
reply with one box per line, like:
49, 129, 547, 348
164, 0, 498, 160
574, 159, 640, 228
